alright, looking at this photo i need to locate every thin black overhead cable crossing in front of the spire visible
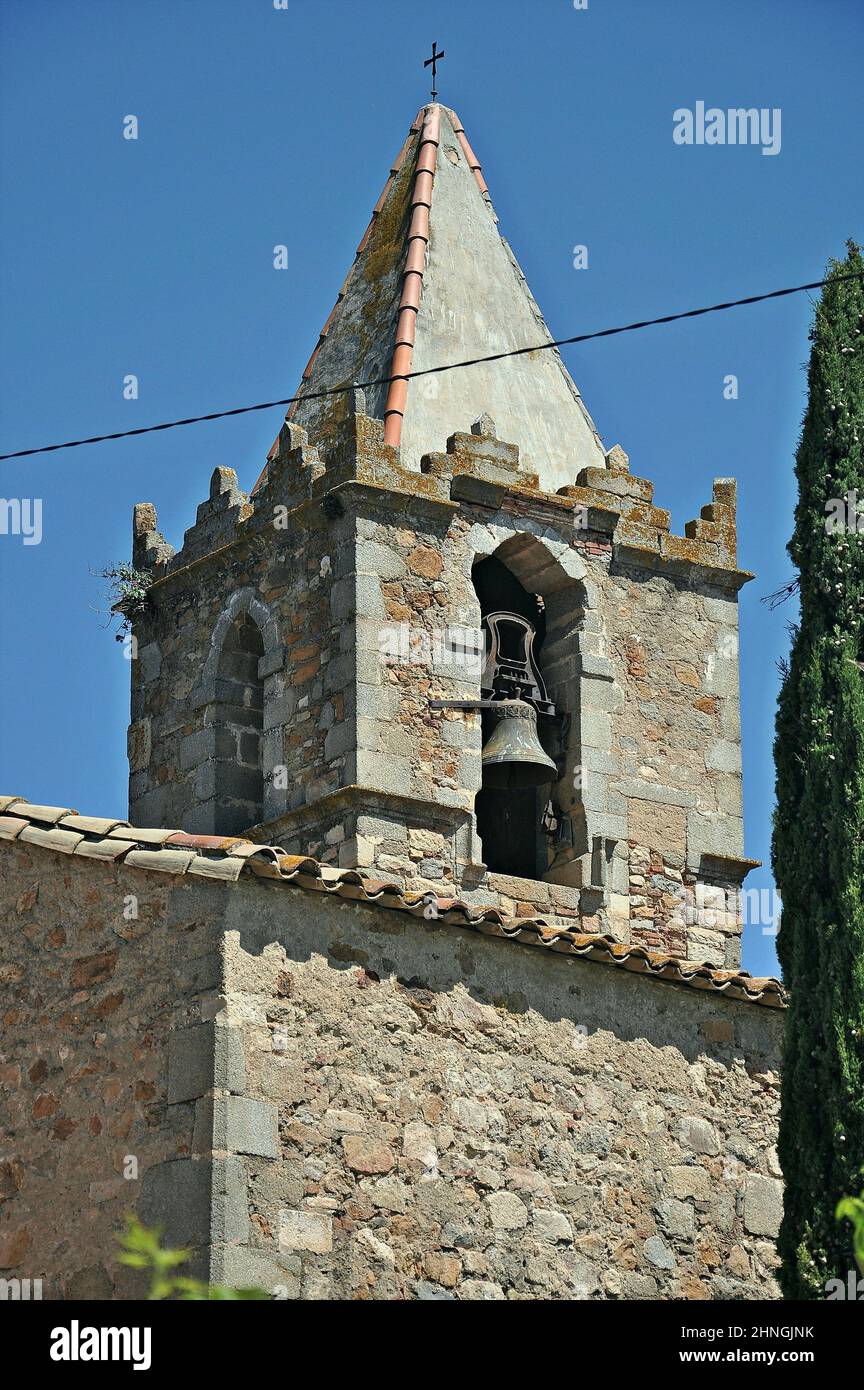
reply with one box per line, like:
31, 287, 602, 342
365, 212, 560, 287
0, 271, 864, 461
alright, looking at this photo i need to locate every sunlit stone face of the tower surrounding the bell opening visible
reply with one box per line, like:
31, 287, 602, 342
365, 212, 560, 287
309, 436, 743, 966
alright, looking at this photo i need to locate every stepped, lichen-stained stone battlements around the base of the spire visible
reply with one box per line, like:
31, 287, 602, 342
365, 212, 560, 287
133, 411, 753, 589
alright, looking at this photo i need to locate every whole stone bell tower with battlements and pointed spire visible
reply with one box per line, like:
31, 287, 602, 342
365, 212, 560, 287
129, 103, 750, 967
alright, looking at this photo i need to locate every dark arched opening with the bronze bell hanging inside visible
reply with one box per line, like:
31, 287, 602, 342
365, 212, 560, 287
471, 556, 560, 878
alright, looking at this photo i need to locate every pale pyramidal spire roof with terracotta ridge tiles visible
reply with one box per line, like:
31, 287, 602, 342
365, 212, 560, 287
268, 103, 606, 492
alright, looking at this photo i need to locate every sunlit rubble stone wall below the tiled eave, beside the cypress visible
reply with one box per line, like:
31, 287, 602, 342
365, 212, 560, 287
225, 885, 781, 1300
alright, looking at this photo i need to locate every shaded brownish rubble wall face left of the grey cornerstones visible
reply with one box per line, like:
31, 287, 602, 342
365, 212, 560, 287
0, 842, 221, 1298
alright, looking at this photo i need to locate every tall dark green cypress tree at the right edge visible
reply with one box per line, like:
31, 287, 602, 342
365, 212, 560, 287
772, 242, 864, 1300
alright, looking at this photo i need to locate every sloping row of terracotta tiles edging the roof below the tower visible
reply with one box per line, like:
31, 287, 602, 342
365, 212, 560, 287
0, 796, 786, 1009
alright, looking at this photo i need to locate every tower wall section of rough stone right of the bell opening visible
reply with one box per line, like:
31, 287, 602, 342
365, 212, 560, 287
606, 571, 745, 966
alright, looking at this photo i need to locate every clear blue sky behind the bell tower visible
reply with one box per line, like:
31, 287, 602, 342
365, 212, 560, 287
0, 0, 864, 973
